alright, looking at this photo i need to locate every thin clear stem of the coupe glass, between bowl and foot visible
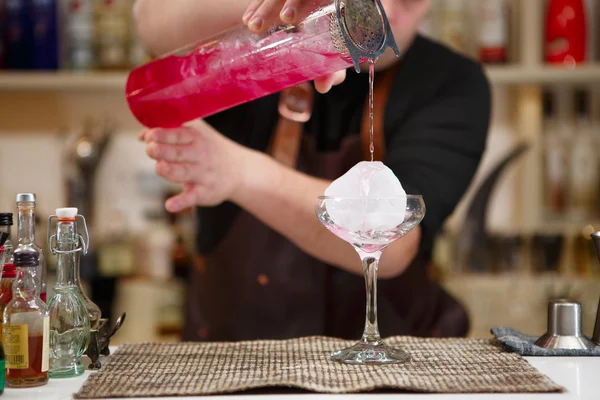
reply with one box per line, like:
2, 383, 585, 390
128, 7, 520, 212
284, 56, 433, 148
358, 251, 381, 344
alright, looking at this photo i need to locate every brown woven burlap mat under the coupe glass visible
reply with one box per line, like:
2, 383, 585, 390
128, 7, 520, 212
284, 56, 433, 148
75, 337, 562, 399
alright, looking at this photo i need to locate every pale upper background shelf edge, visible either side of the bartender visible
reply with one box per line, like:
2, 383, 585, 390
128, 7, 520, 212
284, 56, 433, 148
0, 64, 600, 92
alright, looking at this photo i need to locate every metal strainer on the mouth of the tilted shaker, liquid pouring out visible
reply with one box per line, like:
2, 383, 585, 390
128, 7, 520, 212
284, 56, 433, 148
332, 0, 400, 72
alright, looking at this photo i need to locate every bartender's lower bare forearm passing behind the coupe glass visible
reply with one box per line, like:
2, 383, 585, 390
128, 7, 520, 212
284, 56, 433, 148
232, 148, 420, 277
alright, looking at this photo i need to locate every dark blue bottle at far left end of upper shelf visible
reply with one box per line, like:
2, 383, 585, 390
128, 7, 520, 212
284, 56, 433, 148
4, 0, 33, 69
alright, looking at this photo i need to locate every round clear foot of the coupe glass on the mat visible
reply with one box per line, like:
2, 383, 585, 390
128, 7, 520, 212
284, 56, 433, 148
331, 340, 410, 364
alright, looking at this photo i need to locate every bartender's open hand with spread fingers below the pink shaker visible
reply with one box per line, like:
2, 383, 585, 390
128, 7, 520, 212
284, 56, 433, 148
139, 120, 251, 212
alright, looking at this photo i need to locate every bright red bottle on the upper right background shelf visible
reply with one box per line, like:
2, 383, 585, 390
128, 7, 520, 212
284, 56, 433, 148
544, 0, 587, 66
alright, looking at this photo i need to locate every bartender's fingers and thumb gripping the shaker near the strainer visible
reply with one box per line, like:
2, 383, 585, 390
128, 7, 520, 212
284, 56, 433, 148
242, 0, 346, 93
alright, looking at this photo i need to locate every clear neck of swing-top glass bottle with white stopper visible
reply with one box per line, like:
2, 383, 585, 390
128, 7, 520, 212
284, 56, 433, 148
56, 220, 79, 288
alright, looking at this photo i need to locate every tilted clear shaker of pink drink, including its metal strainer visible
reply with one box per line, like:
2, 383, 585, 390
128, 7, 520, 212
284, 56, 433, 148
126, 0, 399, 128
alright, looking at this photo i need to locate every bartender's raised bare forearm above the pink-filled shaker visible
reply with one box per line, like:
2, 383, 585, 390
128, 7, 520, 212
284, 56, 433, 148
134, 0, 250, 54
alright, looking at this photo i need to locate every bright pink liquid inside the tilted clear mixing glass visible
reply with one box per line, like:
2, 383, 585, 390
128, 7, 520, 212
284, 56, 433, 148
126, 28, 352, 128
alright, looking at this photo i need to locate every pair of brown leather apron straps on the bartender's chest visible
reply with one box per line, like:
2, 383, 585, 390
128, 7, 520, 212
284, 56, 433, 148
267, 62, 400, 168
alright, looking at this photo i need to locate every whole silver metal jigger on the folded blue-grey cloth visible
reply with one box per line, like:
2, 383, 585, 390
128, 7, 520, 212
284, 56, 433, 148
535, 299, 596, 349
